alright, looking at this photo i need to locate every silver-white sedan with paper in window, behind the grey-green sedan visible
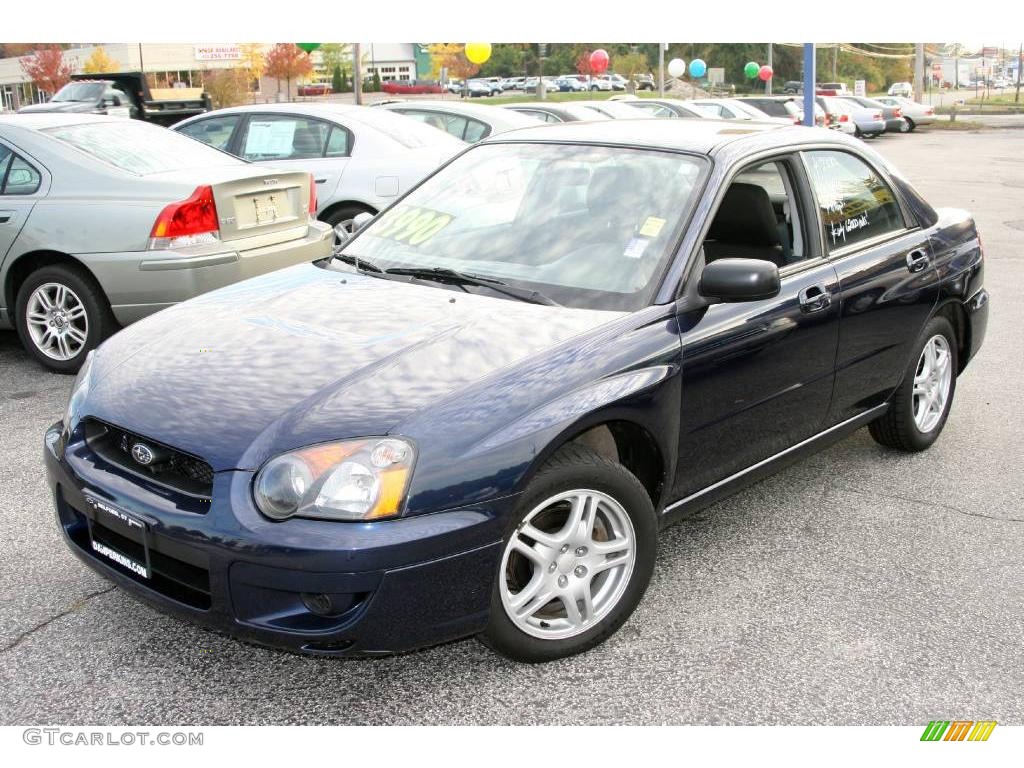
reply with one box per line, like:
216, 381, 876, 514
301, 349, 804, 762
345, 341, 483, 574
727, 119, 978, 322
172, 102, 465, 242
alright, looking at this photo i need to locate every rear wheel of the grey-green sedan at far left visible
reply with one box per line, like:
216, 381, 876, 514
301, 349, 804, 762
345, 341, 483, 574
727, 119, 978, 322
15, 264, 118, 374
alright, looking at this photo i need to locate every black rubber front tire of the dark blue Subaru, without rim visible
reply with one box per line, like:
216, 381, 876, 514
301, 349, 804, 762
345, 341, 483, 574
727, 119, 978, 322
478, 444, 657, 664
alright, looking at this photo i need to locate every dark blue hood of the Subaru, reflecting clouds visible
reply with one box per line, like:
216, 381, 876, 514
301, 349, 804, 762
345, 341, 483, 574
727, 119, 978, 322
86, 264, 621, 471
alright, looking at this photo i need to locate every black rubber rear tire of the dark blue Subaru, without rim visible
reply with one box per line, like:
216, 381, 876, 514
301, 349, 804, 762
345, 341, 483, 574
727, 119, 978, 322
867, 314, 959, 452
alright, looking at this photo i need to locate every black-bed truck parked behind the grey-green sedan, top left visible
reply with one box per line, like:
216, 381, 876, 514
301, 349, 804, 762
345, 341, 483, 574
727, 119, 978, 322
18, 72, 212, 126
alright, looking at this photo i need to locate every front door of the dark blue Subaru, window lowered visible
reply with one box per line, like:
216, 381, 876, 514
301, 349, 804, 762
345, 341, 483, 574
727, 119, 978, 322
674, 156, 839, 499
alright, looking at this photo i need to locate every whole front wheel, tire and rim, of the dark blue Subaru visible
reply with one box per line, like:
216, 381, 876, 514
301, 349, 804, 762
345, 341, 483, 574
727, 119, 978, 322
480, 445, 657, 663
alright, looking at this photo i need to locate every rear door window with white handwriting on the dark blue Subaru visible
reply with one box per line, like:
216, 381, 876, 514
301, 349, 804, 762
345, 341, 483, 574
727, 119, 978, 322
804, 151, 906, 251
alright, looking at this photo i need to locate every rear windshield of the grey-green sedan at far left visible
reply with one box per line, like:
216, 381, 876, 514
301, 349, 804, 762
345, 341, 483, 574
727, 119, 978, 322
43, 120, 240, 176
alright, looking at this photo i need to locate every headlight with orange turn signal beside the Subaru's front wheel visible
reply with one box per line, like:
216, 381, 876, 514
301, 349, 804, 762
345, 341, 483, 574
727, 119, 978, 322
253, 437, 416, 520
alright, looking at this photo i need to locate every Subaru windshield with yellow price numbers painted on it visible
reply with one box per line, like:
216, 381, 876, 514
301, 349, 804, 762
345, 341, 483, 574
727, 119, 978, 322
345, 143, 707, 310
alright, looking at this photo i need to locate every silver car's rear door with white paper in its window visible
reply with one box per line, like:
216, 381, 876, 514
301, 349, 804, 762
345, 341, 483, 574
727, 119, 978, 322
233, 113, 353, 212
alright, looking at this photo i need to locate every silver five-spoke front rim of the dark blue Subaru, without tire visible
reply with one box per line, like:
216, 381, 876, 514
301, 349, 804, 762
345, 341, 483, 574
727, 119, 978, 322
500, 489, 636, 640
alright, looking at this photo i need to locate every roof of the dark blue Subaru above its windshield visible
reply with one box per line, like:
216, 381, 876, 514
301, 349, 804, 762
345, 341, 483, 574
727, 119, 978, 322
482, 119, 819, 155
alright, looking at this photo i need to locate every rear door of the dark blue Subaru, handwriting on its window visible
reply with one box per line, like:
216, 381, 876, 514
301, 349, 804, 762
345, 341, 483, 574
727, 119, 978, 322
803, 150, 939, 424
